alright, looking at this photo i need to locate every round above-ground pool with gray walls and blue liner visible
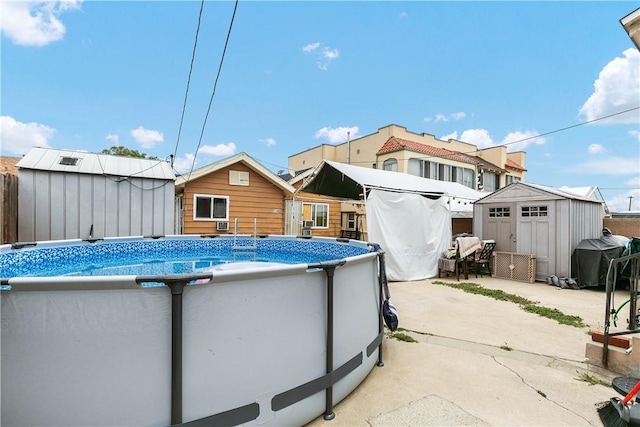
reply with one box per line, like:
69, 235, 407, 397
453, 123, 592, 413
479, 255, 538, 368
0, 235, 384, 426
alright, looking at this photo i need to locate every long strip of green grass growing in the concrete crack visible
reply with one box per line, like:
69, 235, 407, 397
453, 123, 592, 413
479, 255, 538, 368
432, 280, 587, 328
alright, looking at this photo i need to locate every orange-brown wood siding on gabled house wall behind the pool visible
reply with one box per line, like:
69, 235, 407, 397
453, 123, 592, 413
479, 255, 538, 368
183, 163, 285, 234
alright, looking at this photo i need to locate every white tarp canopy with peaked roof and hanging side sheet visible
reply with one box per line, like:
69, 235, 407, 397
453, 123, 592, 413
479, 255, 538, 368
301, 160, 482, 281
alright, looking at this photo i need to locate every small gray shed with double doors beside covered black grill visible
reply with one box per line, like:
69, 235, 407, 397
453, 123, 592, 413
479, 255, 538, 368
473, 182, 603, 281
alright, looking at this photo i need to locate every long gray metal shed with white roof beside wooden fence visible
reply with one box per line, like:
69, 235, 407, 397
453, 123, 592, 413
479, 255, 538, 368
16, 148, 175, 242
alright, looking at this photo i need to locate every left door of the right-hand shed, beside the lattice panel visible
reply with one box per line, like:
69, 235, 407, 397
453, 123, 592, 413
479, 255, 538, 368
482, 203, 516, 252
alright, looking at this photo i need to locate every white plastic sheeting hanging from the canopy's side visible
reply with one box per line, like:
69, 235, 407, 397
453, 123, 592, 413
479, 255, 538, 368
366, 190, 451, 281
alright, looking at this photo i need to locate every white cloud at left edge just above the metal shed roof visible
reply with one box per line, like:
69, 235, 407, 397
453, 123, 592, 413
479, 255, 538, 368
0, 116, 55, 154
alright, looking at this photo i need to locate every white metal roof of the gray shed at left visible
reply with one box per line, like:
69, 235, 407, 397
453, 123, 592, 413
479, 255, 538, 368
16, 148, 176, 180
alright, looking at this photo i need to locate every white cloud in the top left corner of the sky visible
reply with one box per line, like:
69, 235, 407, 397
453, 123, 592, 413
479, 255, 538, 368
0, 0, 82, 46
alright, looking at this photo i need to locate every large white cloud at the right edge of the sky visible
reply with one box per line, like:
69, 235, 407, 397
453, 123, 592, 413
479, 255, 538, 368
580, 48, 640, 124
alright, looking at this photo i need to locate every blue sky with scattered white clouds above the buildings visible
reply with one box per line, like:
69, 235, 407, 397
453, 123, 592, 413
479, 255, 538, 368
0, 0, 640, 211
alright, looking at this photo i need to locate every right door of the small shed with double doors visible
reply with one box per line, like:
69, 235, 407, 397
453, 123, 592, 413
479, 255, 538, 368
518, 202, 556, 281
